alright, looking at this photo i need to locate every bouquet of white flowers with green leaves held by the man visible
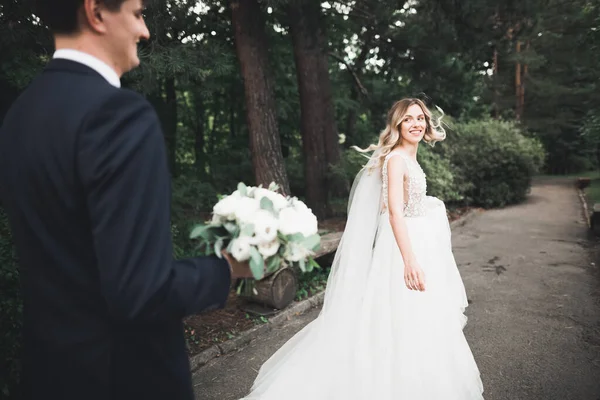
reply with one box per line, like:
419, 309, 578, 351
190, 183, 321, 280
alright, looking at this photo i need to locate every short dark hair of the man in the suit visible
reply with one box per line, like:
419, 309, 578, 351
35, 0, 126, 35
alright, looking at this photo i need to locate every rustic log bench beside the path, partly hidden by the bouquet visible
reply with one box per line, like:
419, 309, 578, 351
241, 232, 342, 310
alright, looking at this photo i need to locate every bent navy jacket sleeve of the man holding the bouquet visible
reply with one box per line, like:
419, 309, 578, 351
77, 90, 230, 322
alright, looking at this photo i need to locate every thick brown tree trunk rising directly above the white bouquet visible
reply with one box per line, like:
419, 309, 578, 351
231, 0, 290, 194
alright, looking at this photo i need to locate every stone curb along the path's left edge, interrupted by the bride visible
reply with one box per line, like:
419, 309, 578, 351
190, 210, 480, 372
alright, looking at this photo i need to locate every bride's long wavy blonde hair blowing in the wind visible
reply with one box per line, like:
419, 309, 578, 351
353, 98, 446, 169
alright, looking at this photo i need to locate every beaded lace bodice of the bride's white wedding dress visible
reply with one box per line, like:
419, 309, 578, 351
381, 153, 427, 217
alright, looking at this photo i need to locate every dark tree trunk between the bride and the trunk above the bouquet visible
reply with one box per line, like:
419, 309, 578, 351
288, 1, 339, 219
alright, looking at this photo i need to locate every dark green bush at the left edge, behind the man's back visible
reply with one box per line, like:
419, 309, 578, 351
0, 207, 22, 398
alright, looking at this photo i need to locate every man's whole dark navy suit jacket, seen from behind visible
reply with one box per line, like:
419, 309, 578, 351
0, 59, 230, 400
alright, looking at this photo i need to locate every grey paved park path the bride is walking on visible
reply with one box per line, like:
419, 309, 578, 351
194, 179, 600, 400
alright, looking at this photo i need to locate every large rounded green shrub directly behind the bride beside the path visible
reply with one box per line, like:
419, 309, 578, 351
333, 120, 544, 210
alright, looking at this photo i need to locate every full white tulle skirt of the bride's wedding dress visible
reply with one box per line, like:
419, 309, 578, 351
239, 197, 483, 400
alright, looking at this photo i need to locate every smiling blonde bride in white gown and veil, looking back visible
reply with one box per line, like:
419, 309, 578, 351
238, 99, 483, 400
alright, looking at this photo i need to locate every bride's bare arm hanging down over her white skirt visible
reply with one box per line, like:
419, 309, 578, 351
387, 157, 425, 291
